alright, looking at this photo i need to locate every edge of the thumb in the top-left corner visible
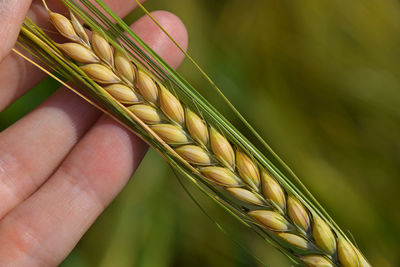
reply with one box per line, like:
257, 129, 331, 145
0, 0, 32, 61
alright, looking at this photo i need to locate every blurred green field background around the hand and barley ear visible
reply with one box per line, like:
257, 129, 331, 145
0, 0, 400, 267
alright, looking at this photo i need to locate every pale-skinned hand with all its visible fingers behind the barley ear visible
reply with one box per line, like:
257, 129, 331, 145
0, 0, 187, 266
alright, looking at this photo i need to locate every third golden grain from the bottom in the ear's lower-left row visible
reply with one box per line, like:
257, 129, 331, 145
248, 210, 290, 231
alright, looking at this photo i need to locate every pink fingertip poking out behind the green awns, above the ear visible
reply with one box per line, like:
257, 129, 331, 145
131, 10, 188, 68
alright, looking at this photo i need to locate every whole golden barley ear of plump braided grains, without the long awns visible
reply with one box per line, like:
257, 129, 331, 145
49, 8, 370, 267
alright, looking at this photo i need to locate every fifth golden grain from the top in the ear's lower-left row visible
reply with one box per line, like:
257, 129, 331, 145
151, 124, 189, 145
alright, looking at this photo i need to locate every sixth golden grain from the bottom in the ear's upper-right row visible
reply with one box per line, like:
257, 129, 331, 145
210, 127, 235, 170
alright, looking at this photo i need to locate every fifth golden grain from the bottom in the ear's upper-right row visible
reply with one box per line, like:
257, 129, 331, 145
236, 150, 260, 190
